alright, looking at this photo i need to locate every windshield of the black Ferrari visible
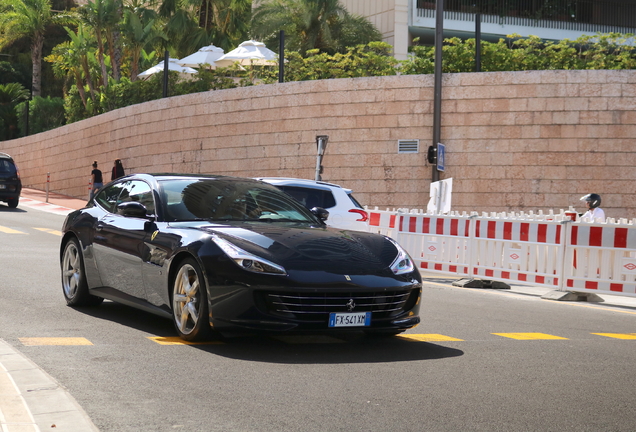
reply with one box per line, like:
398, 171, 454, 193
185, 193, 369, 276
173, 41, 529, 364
159, 178, 318, 224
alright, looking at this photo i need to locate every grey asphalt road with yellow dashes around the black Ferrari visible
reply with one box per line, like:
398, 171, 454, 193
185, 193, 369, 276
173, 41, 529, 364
0, 204, 636, 432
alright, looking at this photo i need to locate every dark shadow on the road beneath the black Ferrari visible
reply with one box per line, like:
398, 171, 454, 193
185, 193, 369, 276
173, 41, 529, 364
76, 301, 464, 364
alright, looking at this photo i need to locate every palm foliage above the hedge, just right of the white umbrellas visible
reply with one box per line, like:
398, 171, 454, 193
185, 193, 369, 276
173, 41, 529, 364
252, 0, 382, 54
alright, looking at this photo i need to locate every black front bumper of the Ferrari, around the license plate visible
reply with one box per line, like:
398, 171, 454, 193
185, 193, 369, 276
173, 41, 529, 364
208, 283, 422, 334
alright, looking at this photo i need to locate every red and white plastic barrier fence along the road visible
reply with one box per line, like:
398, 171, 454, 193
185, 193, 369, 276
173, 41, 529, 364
367, 208, 636, 296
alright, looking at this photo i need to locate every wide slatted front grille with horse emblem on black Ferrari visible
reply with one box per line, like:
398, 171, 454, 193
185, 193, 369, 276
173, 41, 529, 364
264, 289, 419, 321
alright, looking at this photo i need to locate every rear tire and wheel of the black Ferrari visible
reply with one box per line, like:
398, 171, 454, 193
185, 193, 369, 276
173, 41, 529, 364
60, 237, 104, 306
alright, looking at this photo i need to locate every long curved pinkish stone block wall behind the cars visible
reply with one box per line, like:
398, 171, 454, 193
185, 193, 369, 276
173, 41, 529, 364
0, 71, 636, 218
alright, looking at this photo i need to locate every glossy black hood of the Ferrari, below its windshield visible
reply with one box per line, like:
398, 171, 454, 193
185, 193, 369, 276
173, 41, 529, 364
200, 223, 398, 275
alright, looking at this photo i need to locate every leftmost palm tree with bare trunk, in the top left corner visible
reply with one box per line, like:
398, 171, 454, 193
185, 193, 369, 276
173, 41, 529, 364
0, 0, 69, 96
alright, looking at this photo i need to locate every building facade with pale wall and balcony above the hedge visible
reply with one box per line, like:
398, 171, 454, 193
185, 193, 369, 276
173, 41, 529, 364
341, 0, 636, 60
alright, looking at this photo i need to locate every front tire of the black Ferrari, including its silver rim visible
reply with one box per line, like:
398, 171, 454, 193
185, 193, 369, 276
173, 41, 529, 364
171, 258, 212, 341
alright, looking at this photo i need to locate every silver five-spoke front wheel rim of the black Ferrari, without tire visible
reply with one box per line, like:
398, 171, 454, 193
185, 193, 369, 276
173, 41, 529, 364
172, 264, 201, 335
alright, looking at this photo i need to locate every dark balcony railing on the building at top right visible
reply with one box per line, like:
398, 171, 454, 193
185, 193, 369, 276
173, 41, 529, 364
416, 0, 636, 33
